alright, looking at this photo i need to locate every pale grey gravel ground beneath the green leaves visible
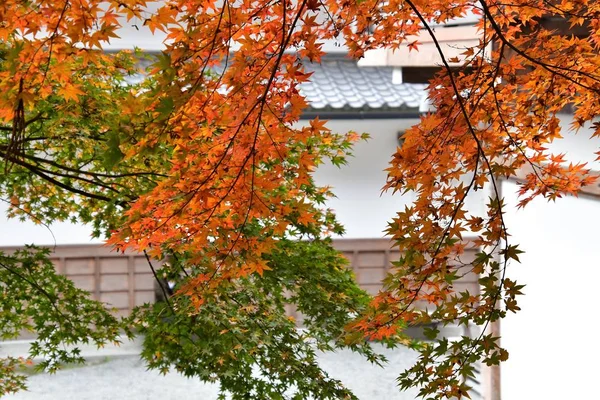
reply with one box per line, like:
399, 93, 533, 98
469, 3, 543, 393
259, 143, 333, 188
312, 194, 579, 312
5, 348, 415, 400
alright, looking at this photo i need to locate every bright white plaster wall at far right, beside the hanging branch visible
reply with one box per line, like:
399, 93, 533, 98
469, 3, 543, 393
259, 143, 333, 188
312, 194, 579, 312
501, 115, 600, 400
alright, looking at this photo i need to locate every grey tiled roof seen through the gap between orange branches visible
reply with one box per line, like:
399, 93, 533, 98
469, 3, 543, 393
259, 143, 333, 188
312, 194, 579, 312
300, 59, 427, 111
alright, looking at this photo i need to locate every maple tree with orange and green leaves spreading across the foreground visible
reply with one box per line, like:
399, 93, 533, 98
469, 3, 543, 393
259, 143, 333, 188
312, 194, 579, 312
0, 0, 600, 398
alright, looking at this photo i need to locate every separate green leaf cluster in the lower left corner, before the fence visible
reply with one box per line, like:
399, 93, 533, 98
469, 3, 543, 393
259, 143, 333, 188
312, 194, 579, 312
0, 246, 120, 393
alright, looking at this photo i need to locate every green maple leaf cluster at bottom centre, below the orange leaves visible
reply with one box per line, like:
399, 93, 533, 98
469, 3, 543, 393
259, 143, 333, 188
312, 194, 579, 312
129, 240, 383, 399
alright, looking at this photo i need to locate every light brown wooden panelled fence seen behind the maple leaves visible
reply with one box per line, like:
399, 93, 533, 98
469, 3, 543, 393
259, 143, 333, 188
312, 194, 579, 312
0, 239, 479, 317
